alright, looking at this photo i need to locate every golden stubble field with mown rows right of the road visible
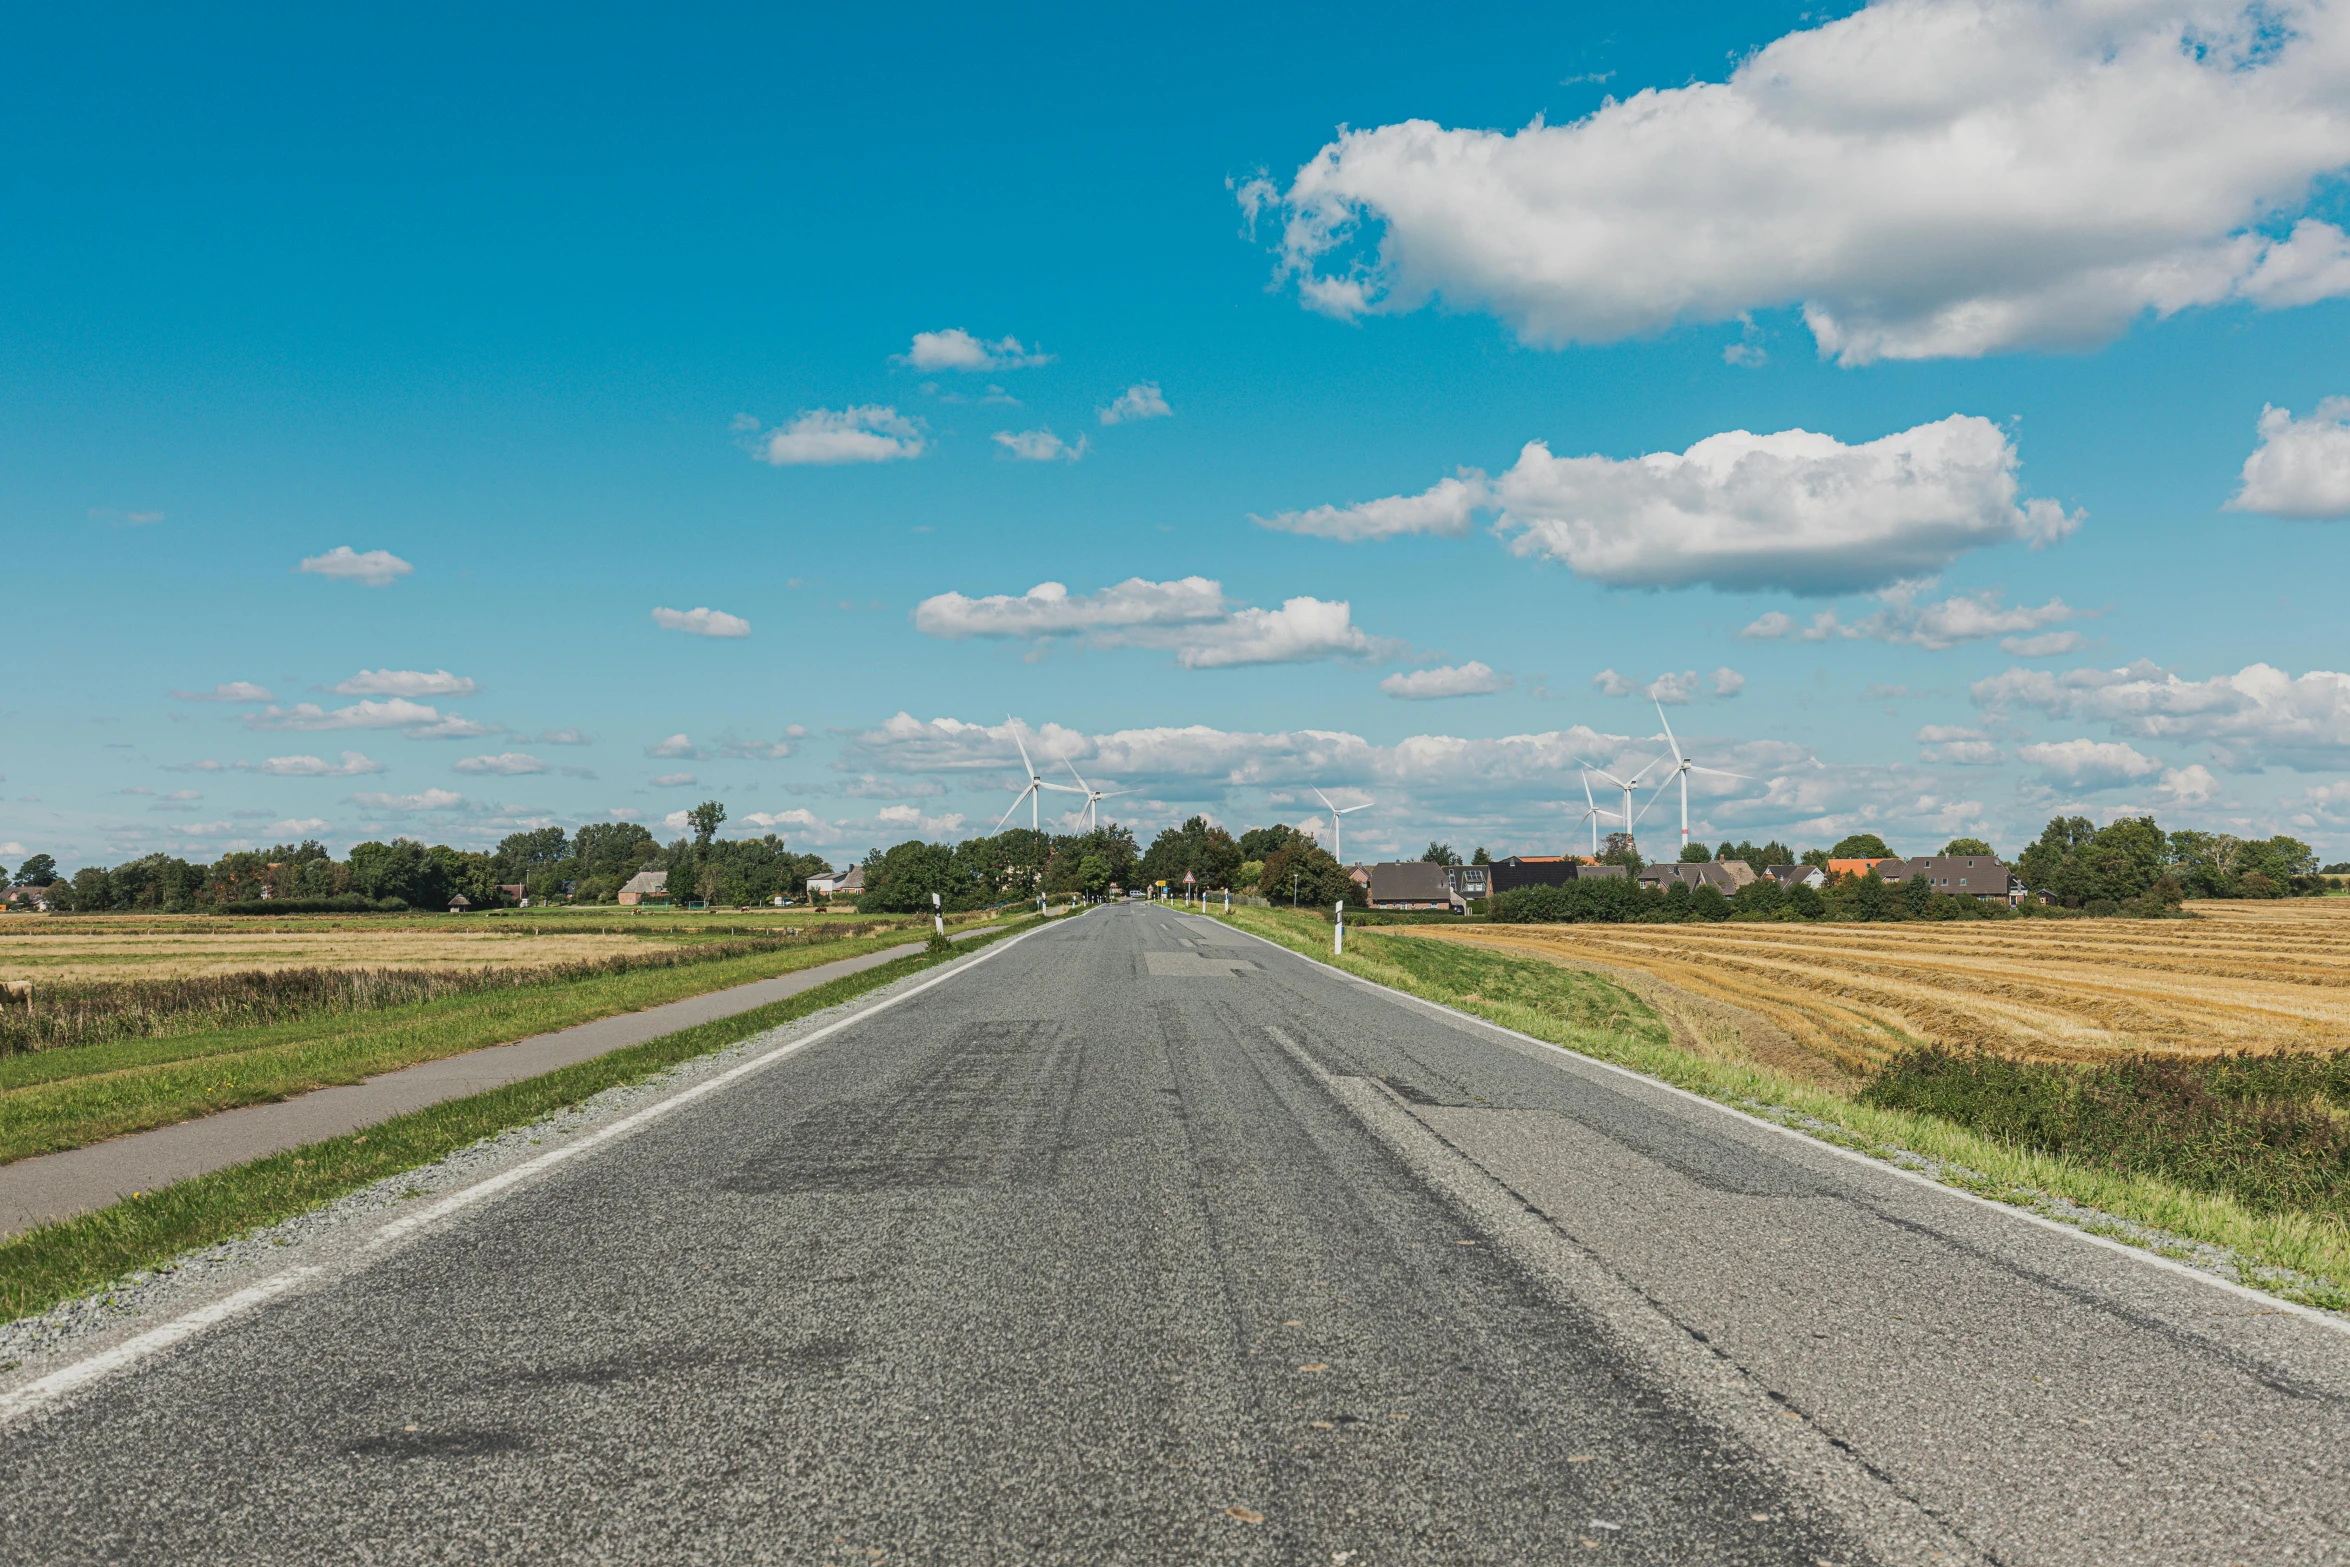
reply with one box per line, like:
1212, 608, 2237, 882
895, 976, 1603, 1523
1410, 897, 2350, 1071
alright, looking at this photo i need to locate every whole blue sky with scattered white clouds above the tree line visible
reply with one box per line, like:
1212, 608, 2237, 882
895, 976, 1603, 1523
0, 0, 2350, 865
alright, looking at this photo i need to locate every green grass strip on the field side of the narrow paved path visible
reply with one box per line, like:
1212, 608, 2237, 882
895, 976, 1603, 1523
0, 930, 968, 1163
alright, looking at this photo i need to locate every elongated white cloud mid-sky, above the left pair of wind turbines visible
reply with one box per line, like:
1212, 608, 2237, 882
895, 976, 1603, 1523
914, 576, 1391, 670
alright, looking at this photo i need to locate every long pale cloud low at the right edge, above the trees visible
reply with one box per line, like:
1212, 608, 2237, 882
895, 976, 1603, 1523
1972, 658, 2350, 768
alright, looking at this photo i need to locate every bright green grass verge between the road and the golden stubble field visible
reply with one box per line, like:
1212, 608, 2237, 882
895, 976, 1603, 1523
1227, 909, 2350, 1311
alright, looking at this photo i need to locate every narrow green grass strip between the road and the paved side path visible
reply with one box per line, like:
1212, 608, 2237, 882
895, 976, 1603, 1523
0, 919, 1036, 1323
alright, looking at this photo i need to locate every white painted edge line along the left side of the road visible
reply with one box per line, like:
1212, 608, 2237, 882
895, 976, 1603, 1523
0, 926, 1058, 1428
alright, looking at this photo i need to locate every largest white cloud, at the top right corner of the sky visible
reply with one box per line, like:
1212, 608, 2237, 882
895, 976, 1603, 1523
1238, 0, 2350, 364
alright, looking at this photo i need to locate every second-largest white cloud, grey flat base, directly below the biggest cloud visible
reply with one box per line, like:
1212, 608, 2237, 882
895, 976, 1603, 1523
1495, 413, 2080, 594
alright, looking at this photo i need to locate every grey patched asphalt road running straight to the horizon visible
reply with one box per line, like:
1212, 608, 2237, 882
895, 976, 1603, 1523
0, 907, 2350, 1567
